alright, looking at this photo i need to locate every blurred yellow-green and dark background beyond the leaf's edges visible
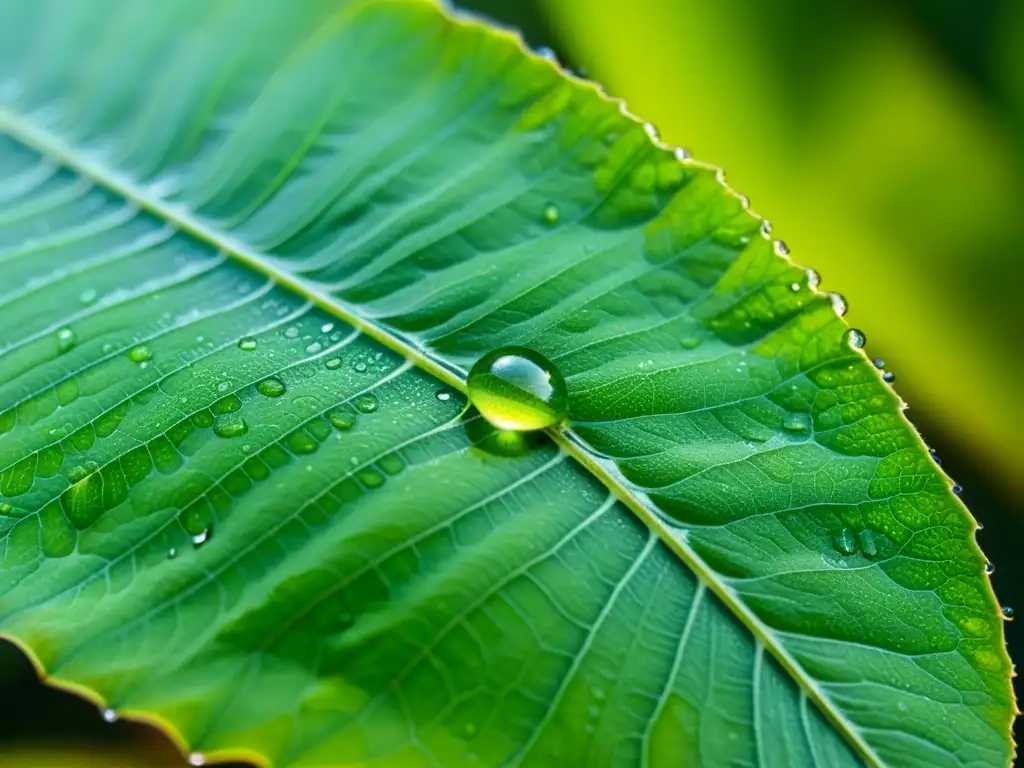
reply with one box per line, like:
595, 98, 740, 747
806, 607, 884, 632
0, 0, 1024, 768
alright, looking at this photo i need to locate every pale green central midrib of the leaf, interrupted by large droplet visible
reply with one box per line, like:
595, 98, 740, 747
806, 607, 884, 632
0, 106, 883, 766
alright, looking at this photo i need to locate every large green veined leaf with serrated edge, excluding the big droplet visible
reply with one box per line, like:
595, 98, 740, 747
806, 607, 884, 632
0, 0, 1014, 768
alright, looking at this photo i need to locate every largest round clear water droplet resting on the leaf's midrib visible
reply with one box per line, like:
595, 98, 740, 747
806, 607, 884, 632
467, 347, 568, 431
